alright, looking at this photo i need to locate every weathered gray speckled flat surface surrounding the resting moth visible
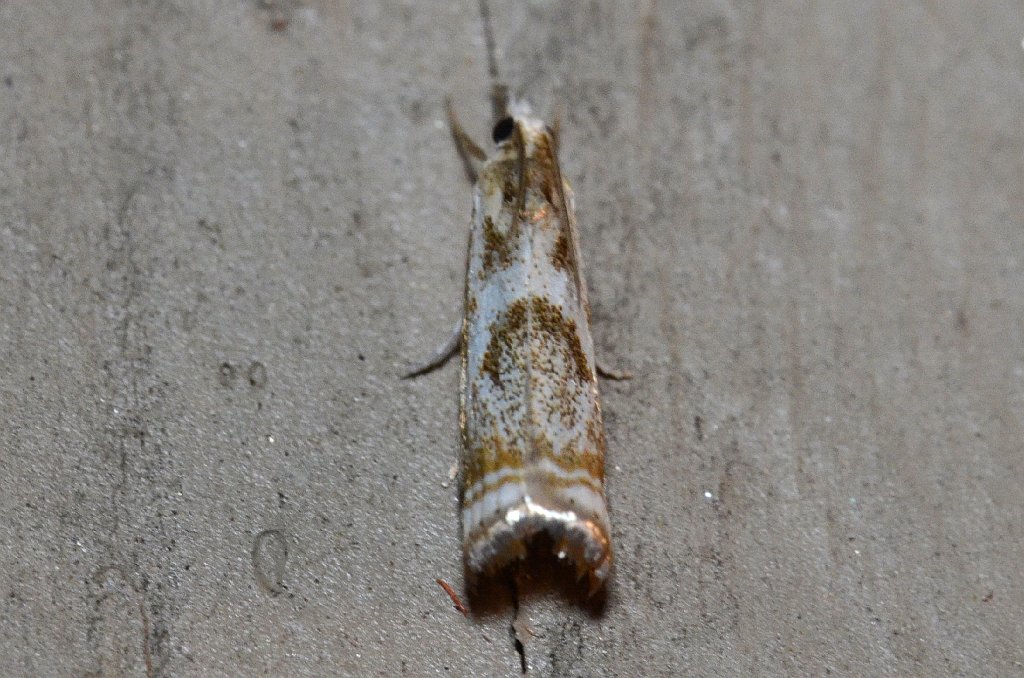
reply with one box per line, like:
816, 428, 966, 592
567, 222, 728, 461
0, 0, 1024, 676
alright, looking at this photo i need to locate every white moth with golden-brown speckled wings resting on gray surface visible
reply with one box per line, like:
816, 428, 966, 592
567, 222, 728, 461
408, 86, 628, 594
